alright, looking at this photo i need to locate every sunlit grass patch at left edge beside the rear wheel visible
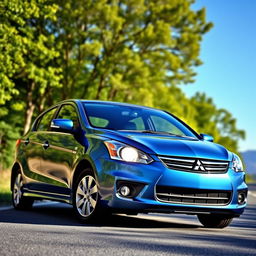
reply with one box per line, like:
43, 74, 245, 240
0, 170, 11, 204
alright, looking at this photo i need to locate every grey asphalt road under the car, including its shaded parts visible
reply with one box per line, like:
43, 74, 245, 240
0, 186, 256, 256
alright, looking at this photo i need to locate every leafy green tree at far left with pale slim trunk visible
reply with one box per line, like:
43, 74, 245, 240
0, 0, 61, 132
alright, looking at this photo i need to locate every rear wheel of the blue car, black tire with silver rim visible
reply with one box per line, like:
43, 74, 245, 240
12, 170, 34, 210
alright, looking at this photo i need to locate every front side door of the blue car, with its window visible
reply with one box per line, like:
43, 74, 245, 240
41, 104, 82, 194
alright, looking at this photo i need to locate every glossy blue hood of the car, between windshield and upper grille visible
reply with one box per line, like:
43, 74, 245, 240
99, 132, 232, 161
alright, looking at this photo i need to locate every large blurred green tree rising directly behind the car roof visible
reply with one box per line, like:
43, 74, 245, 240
55, 0, 212, 106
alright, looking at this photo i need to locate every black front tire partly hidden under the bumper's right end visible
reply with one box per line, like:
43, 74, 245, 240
197, 214, 233, 228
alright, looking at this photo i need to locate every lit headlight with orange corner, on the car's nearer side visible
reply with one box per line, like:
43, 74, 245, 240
104, 140, 153, 164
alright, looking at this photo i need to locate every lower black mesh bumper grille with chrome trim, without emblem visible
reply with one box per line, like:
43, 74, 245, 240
156, 186, 232, 205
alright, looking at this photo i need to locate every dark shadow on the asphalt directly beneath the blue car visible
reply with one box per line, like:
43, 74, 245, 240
0, 203, 201, 229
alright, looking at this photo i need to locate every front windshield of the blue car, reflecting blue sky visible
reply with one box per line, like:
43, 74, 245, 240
83, 102, 199, 138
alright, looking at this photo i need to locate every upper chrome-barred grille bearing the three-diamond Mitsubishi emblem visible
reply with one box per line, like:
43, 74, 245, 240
159, 156, 229, 173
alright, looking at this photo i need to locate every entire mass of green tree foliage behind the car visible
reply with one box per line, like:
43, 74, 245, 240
0, 0, 244, 171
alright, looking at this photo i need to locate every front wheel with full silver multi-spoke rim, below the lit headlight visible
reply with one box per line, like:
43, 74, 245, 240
73, 169, 100, 223
